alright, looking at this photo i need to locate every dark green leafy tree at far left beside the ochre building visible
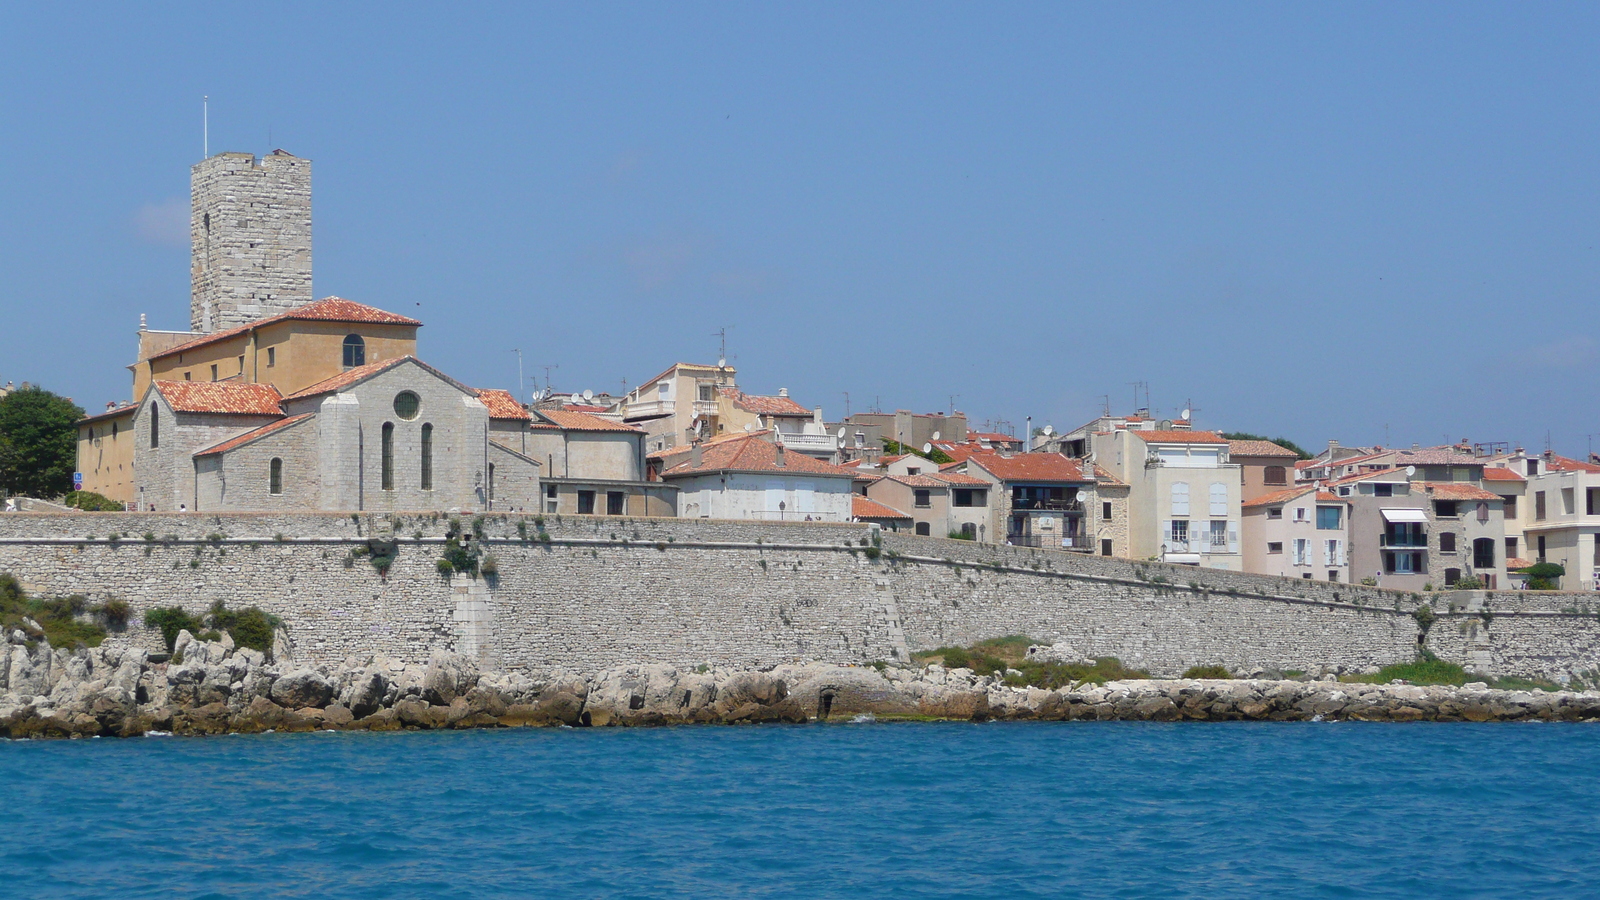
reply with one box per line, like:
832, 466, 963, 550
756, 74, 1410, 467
0, 388, 83, 496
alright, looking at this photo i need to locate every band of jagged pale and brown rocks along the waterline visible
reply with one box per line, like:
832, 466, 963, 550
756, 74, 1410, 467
0, 631, 1600, 738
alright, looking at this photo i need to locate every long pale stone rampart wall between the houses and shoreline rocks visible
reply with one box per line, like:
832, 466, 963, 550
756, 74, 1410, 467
0, 512, 1600, 679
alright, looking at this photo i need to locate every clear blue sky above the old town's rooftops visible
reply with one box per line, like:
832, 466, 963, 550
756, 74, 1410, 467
0, 3, 1600, 455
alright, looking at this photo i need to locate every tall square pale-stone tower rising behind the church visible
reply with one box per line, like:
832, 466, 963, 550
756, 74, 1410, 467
189, 151, 312, 333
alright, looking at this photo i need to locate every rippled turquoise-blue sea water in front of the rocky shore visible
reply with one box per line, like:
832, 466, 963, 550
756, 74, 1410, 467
0, 722, 1600, 900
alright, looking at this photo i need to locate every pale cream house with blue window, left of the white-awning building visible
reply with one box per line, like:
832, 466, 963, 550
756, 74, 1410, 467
1242, 485, 1350, 581
